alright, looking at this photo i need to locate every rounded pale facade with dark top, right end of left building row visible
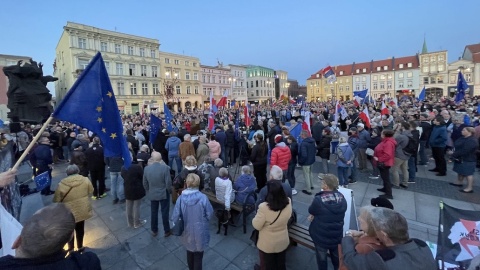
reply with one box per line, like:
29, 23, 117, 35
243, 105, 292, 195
246, 65, 276, 104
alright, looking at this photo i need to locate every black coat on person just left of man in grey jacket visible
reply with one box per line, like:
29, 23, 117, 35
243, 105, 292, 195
121, 163, 145, 201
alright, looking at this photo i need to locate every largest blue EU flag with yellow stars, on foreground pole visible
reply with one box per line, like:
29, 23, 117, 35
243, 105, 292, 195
53, 53, 132, 168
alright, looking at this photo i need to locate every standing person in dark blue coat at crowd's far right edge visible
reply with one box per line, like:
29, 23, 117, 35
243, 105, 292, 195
448, 127, 478, 193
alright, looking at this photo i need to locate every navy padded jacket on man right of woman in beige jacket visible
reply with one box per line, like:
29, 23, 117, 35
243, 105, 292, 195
308, 191, 347, 248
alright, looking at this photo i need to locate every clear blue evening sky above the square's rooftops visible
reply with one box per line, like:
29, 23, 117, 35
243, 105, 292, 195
0, 0, 480, 95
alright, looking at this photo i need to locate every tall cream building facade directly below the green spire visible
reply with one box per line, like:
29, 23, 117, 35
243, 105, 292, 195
419, 51, 449, 98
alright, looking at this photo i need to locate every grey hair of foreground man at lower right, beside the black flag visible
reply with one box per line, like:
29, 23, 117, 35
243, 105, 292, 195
371, 207, 410, 244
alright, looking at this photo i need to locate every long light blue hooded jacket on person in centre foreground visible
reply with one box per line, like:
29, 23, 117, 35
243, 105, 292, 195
171, 188, 213, 252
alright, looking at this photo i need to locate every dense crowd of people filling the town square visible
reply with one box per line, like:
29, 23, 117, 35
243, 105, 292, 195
0, 96, 480, 269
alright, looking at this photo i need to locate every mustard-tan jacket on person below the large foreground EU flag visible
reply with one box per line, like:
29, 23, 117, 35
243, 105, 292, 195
53, 174, 93, 222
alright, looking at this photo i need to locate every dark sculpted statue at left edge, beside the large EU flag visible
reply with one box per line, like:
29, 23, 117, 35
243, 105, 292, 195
3, 59, 58, 123
